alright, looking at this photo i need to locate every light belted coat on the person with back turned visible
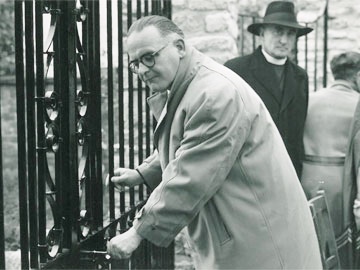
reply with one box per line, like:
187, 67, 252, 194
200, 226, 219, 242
301, 80, 359, 237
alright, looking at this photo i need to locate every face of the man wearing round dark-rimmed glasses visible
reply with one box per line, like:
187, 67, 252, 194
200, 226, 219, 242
127, 26, 184, 92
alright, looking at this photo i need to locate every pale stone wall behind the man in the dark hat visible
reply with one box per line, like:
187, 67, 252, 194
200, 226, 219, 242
173, 0, 360, 90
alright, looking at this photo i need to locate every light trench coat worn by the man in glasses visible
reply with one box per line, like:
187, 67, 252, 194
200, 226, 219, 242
134, 49, 321, 269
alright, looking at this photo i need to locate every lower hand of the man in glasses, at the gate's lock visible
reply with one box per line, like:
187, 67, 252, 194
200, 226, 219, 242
107, 228, 143, 259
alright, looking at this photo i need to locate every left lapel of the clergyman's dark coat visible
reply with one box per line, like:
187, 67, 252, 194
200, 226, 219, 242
250, 47, 282, 104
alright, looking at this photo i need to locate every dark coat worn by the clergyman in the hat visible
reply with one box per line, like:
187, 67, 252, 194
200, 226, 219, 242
225, 46, 309, 177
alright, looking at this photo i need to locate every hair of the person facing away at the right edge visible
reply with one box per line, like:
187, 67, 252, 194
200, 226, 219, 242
330, 52, 360, 80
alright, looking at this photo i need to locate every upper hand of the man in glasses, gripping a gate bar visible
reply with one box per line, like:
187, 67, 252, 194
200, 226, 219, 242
111, 168, 144, 191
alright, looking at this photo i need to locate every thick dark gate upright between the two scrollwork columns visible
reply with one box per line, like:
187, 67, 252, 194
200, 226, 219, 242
59, 1, 80, 262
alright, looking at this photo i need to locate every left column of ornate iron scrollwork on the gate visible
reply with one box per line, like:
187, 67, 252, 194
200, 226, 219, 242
36, 1, 64, 263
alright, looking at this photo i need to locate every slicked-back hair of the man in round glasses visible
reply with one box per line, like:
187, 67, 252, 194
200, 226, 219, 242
128, 15, 185, 38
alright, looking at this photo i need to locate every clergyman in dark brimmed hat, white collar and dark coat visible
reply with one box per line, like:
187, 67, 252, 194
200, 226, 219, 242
225, 1, 312, 177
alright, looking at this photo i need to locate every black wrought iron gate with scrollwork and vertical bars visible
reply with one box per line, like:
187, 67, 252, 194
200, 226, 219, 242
9, 0, 174, 269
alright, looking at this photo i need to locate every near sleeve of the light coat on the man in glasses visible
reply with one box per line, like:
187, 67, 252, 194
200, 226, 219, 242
134, 80, 250, 246
